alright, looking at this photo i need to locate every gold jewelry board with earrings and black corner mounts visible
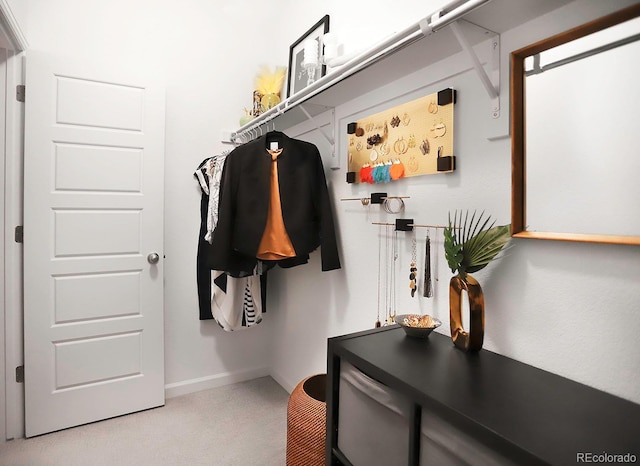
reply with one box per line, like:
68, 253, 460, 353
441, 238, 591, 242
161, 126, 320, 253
347, 88, 456, 183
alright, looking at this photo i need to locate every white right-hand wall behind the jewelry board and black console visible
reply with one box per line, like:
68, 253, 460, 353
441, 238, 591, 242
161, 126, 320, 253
264, 1, 640, 408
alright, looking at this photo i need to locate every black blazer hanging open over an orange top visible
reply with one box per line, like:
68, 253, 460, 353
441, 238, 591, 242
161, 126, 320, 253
209, 131, 340, 276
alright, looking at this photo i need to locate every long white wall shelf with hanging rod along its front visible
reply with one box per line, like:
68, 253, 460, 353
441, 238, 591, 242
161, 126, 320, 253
232, 0, 572, 139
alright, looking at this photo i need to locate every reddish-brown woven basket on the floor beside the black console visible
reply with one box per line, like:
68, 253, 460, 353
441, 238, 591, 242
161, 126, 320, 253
287, 374, 327, 466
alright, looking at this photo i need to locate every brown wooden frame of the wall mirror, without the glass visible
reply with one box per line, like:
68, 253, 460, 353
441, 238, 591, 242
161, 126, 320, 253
511, 4, 640, 245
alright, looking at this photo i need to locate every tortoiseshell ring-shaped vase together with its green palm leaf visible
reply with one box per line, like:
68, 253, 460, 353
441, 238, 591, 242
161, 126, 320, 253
444, 211, 511, 351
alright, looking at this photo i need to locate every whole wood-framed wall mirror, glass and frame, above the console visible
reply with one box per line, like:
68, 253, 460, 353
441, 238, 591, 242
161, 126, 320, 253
511, 4, 640, 245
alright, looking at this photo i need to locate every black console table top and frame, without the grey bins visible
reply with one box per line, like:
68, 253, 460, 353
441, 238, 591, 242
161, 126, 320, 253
326, 325, 640, 465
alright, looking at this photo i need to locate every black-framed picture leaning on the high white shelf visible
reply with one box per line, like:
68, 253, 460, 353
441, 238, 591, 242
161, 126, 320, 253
287, 15, 329, 97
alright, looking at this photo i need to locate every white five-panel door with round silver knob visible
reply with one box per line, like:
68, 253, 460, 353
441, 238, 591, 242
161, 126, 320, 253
24, 52, 165, 437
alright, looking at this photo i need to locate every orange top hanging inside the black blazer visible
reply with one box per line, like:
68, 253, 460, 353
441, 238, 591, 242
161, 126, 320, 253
256, 149, 296, 260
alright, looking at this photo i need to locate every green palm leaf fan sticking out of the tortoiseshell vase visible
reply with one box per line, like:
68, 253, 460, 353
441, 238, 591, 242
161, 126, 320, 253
444, 211, 511, 282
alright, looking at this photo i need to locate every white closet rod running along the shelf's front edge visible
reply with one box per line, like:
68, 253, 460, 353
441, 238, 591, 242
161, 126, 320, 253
231, 0, 491, 140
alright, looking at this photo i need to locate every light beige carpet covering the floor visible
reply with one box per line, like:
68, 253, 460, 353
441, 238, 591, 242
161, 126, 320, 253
0, 377, 289, 466
